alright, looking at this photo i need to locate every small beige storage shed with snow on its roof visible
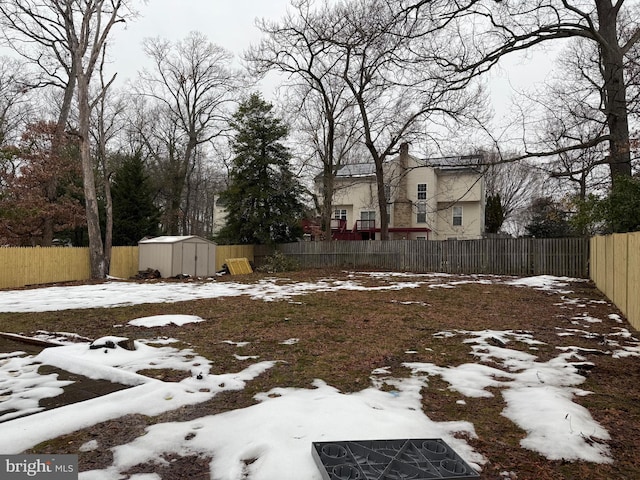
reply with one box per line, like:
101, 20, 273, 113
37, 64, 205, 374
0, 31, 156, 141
138, 235, 216, 278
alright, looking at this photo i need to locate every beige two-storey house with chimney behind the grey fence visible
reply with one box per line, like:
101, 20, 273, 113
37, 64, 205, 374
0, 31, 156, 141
324, 144, 485, 240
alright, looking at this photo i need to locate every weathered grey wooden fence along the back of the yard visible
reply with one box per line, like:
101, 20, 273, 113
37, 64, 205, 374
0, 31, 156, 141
278, 238, 589, 278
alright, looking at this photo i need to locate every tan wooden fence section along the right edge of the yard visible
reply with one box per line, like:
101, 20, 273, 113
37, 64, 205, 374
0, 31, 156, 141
590, 232, 640, 330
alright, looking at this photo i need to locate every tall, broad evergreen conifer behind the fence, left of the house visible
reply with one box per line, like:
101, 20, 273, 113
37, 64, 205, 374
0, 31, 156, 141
216, 93, 304, 244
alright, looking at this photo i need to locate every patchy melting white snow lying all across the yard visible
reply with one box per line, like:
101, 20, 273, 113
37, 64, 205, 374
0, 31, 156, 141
0, 273, 640, 480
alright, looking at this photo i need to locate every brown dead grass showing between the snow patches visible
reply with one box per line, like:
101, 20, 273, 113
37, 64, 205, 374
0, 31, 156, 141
0, 271, 640, 480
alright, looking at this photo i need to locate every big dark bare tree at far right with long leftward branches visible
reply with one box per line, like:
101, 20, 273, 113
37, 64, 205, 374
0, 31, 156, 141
400, 0, 640, 185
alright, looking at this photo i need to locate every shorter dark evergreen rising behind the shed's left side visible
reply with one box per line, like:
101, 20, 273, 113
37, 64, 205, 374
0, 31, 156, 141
111, 155, 160, 246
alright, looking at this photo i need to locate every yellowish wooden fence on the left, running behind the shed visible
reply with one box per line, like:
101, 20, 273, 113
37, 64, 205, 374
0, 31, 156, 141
0, 245, 253, 288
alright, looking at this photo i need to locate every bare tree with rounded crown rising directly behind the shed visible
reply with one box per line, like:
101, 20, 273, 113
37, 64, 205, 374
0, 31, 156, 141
138, 32, 244, 235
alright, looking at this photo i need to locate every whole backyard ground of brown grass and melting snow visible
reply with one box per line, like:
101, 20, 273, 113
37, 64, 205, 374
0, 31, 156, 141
0, 272, 640, 480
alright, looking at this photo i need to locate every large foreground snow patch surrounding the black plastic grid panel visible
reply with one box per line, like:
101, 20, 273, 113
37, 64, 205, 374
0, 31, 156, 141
89, 379, 484, 480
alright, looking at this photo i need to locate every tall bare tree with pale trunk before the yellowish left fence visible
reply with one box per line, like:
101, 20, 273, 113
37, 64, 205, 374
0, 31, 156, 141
0, 0, 131, 278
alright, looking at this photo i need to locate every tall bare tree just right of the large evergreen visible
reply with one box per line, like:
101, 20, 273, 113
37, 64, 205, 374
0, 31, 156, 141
246, 0, 360, 240
